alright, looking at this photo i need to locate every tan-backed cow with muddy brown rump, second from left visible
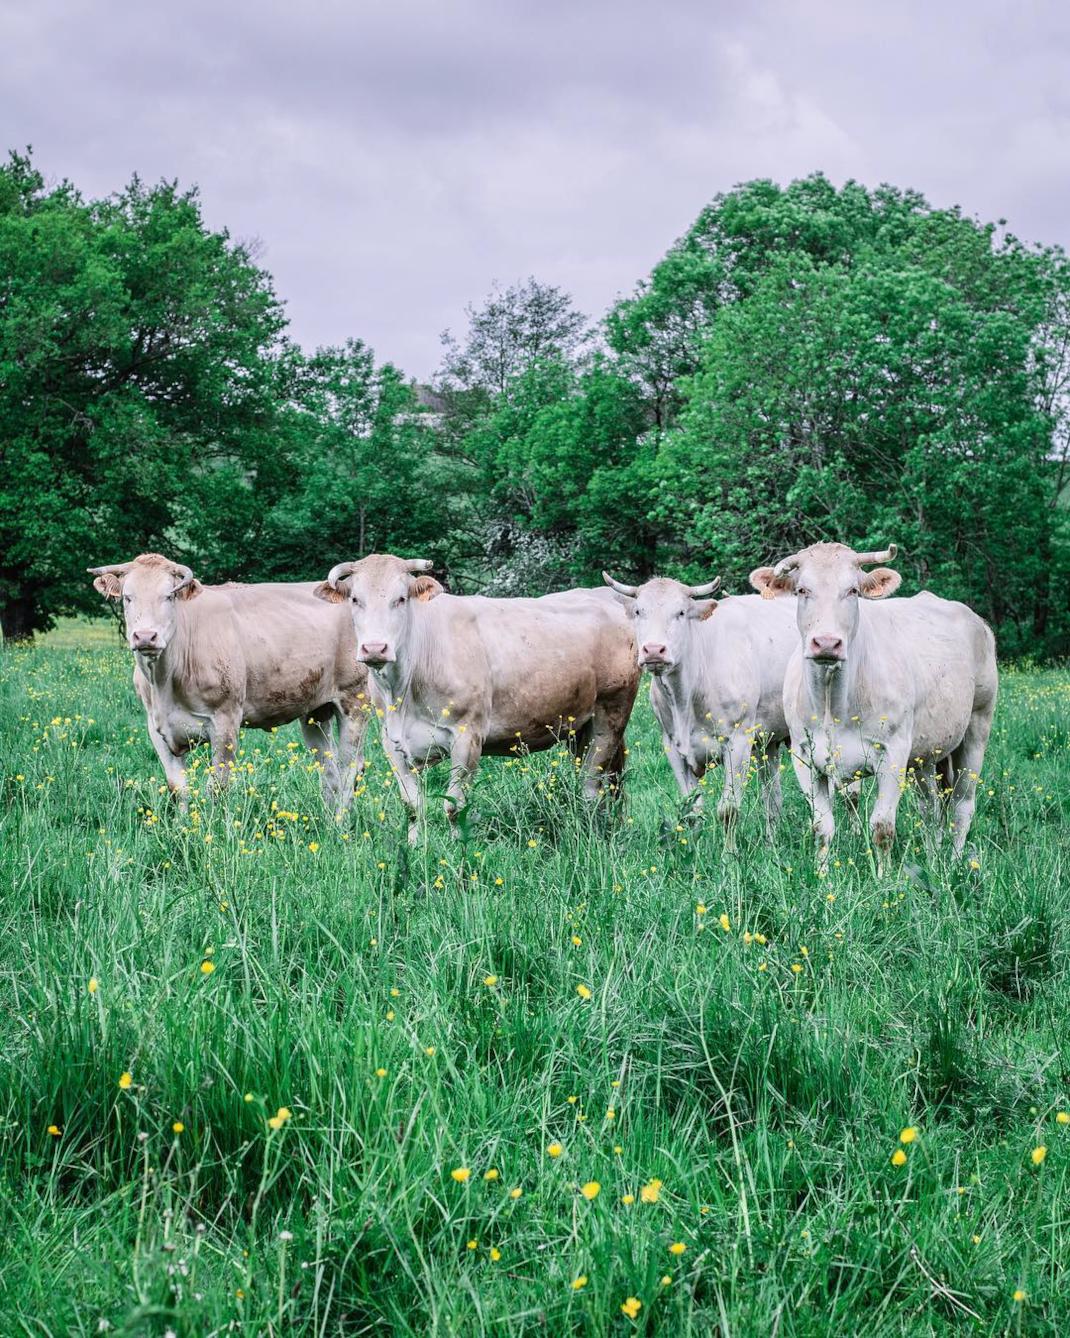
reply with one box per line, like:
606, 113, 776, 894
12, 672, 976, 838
316, 554, 639, 842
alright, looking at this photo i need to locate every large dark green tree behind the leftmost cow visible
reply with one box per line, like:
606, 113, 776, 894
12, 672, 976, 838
0, 154, 284, 638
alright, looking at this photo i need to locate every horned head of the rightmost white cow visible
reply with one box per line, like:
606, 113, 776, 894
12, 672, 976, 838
750, 543, 903, 666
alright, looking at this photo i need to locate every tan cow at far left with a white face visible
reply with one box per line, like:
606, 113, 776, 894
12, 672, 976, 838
88, 553, 370, 815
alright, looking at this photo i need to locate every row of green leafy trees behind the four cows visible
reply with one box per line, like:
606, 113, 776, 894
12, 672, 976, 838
0, 154, 1070, 657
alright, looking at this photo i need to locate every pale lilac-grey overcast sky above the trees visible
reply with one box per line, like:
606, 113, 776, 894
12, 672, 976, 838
0, 0, 1070, 379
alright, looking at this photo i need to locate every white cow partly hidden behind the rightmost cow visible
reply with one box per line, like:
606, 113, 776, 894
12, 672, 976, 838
602, 571, 797, 847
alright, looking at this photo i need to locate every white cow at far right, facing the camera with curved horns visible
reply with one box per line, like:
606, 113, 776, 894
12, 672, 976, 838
750, 543, 998, 870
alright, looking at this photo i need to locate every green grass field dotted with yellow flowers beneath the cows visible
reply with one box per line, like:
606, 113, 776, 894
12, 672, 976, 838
0, 629, 1070, 1335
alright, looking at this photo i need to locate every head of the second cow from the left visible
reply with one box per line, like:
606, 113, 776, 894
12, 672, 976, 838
313, 553, 443, 669
